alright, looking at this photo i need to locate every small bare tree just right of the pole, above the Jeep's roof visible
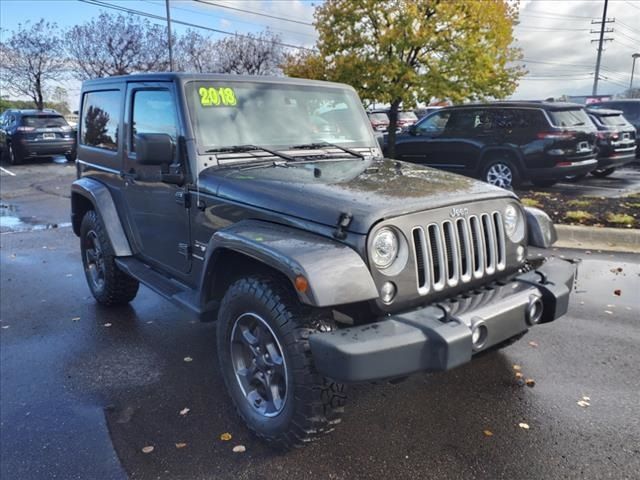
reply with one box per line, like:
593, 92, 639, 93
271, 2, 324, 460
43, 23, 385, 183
174, 30, 220, 73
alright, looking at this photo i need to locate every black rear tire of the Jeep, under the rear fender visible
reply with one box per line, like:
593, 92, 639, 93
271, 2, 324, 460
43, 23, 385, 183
80, 210, 140, 306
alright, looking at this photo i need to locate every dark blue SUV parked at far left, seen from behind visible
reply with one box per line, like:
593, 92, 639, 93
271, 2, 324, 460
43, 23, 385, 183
0, 109, 76, 165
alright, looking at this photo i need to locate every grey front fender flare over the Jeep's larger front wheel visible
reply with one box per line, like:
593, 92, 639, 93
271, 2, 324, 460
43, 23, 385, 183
200, 220, 378, 307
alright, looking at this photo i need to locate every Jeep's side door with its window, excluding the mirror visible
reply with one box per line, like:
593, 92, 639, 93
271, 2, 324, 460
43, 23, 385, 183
122, 82, 191, 275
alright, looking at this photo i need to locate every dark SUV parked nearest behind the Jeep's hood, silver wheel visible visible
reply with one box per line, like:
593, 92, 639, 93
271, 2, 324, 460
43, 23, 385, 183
396, 102, 597, 188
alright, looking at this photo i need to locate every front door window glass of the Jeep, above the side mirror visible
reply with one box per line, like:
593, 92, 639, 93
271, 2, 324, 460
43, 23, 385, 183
129, 90, 178, 152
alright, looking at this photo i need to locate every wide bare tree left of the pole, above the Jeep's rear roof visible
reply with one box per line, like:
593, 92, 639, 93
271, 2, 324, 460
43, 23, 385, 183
67, 12, 169, 80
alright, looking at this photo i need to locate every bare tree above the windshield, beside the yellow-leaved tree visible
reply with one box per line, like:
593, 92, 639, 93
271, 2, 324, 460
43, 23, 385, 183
214, 31, 284, 75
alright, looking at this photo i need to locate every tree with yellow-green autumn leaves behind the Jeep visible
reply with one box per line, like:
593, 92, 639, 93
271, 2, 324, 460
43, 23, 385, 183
283, 0, 525, 156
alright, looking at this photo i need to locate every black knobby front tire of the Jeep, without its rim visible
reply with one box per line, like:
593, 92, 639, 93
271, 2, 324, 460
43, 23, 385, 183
217, 275, 346, 450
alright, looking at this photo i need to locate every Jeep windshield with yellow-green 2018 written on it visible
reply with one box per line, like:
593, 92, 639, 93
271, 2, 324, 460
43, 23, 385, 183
186, 81, 376, 153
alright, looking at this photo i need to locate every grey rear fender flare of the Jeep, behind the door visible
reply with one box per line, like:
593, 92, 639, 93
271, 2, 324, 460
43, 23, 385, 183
71, 177, 132, 257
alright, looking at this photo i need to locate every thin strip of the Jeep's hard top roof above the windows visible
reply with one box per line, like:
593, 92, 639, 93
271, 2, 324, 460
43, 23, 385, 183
82, 72, 353, 90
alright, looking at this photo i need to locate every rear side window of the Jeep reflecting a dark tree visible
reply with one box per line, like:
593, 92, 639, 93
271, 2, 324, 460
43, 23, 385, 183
80, 90, 120, 150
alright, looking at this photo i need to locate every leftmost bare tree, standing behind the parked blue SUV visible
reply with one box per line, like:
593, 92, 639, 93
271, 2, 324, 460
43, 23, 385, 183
0, 19, 66, 110
